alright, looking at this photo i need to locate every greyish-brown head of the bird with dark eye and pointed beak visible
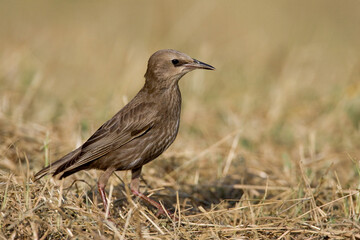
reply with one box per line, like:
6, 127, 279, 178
145, 49, 215, 86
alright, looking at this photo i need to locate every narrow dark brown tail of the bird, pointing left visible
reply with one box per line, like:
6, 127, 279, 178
34, 147, 81, 181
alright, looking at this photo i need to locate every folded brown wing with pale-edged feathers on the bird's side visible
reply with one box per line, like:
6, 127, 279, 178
55, 103, 157, 175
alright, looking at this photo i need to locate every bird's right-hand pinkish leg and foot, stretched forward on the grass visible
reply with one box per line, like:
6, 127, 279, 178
130, 167, 176, 219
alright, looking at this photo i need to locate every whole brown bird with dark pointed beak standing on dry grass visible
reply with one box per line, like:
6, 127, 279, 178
35, 49, 215, 218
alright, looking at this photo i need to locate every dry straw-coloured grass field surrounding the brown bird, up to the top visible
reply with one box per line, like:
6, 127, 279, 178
0, 1, 360, 239
